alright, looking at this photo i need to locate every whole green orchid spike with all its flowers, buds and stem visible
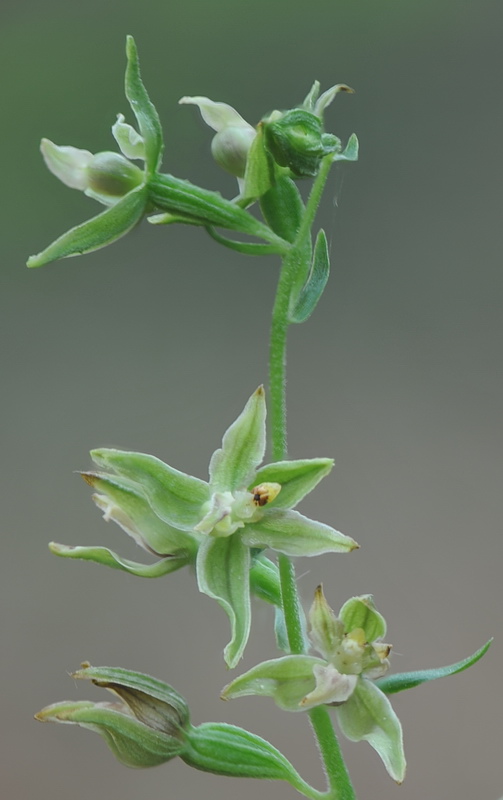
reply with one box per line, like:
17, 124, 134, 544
32, 37, 490, 800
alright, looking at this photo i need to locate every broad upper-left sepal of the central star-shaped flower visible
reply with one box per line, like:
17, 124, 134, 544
91, 449, 210, 530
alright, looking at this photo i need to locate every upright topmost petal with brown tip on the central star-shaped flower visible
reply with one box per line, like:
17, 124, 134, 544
209, 386, 266, 492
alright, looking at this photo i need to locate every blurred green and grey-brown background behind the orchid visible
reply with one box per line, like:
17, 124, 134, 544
0, 0, 503, 800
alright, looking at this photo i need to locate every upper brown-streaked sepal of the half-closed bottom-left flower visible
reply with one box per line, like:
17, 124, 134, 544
72, 663, 190, 736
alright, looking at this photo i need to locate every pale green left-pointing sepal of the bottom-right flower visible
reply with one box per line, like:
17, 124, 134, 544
221, 655, 326, 711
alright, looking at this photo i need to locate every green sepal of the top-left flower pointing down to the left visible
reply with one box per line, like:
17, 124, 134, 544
27, 185, 147, 267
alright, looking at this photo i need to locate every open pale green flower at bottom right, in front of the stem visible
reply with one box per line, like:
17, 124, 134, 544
222, 586, 406, 783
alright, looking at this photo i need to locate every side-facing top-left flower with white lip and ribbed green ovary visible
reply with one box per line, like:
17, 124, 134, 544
28, 36, 286, 267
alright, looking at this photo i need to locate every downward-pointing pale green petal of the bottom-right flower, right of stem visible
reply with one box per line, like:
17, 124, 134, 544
336, 678, 406, 783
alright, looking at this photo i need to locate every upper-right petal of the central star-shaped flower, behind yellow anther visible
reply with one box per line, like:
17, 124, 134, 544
252, 458, 334, 508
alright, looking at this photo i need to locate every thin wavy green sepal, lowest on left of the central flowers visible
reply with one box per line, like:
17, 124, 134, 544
49, 542, 193, 578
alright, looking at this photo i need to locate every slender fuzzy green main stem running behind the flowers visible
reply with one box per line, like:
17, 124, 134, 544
269, 161, 356, 800
